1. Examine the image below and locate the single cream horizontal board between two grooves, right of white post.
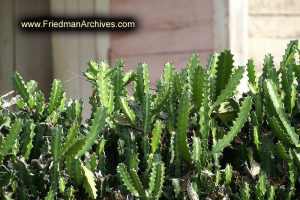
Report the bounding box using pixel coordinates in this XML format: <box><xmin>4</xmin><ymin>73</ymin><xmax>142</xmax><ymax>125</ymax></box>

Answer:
<box><xmin>249</xmin><ymin>15</ymin><xmax>300</xmax><ymax>39</ymax></box>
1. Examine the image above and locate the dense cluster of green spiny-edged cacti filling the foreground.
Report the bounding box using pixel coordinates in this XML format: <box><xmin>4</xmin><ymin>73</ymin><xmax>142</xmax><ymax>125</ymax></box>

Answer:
<box><xmin>0</xmin><ymin>40</ymin><xmax>300</xmax><ymax>200</ymax></box>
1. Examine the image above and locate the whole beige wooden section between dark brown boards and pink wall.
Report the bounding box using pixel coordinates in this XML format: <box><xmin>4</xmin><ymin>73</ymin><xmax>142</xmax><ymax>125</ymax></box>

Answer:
<box><xmin>51</xmin><ymin>0</ymin><xmax>109</xmax><ymax>118</ymax></box>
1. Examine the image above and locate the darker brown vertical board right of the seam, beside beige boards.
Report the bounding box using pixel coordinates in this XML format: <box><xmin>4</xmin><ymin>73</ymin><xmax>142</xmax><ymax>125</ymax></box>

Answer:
<box><xmin>14</xmin><ymin>0</ymin><xmax>52</xmax><ymax>93</ymax></box>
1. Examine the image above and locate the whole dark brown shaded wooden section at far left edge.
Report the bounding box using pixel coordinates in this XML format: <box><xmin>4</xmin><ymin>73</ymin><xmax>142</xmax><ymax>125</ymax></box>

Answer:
<box><xmin>0</xmin><ymin>0</ymin><xmax>52</xmax><ymax>96</ymax></box>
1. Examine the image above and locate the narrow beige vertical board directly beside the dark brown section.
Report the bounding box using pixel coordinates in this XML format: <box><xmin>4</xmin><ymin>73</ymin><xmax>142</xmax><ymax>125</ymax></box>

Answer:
<box><xmin>51</xmin><ymin>0</ymin><xmax>81</xmax><ymax>98</ymax></box>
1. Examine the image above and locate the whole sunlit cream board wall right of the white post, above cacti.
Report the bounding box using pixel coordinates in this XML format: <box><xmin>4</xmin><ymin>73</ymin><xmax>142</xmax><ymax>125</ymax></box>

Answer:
<box><xmin>248</xmin><ymin>0</ymin><xmax>300</xmax><ymax>70</ymax></box>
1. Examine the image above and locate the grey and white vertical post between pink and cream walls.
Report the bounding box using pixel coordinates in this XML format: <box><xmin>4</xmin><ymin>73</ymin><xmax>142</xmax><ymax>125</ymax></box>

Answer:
<box><xmin>213</xmin><ymin>0</ymin><xmax>248</xmax><ymax>65</ymax></box>
